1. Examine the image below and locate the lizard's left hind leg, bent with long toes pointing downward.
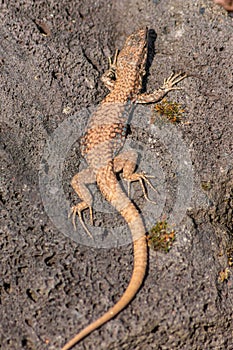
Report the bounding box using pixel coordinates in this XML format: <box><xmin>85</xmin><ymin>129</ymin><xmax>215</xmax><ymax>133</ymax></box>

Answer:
<box><xmin>69</xmin><ymin>168</ymin><xmax>96</xmax><ymax>238</ymax></box>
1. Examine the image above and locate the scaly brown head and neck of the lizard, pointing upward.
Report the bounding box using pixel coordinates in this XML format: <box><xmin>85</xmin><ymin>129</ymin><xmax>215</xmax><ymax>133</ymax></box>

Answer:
<box><xmin>116</xmin><ymin>27</ymin><xmax>148</xmax><ymax>92</ymax></box>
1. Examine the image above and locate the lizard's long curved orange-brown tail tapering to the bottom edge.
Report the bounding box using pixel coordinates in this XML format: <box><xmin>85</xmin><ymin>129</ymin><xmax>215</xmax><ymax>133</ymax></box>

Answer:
<box><xmin>62</xmin><ymin>167</ymin><xmax>147</xmax><ymax>350</ymax></box>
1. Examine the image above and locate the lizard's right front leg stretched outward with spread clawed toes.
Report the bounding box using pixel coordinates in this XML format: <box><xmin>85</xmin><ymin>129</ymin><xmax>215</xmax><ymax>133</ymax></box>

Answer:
<box><xmin>135</xmin><ymin>73</ymin><xmax>187</xmax><ymax>103</ymax></box>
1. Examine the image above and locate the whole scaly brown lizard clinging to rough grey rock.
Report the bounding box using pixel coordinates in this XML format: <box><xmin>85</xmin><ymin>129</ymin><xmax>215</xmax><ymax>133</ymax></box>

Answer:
<box><xmin>62</xmin><ymin>28</ymin><xmax>186</xmax><ymax>350</ymax></box>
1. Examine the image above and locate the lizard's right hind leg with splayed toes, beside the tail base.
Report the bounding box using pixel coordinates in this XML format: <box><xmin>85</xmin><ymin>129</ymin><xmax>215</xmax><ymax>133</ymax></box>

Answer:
<box><xmin>114</xmin><ymin>150</ymin><xmax>157</xmax><ymax>204</ymax></box>
